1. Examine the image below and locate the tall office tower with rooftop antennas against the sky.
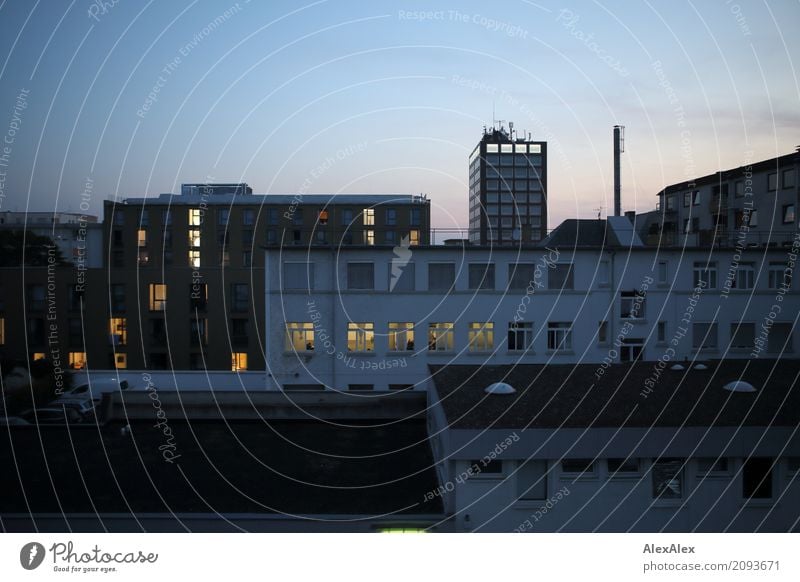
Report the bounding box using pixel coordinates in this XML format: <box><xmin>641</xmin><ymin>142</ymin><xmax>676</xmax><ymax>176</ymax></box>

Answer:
<box><xmin>469</xmin><ymin>125</ymin><xmax>547</xmax><ymax>245</ymax></box>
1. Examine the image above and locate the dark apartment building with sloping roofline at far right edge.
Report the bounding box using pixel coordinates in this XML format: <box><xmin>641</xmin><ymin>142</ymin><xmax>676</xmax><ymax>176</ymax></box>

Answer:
<box><xmin>642</xmin><ymin>152</ymin><xmax>800</xmax><ymax>247</ymax></box>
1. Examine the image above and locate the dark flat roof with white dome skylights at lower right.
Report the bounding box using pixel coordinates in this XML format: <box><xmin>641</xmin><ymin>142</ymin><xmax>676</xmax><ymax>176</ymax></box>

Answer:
<box><xmin>430</xmin><ymin>359</ymin><xmax>800</xmax><ymax>429</ymax></box>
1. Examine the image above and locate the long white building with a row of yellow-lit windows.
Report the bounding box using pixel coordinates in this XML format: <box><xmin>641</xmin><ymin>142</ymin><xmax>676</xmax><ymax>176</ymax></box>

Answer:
<box><xmin>264</xmin><ymin>217</ymin><xmax>800</xmax><ymax>390</ymax></box>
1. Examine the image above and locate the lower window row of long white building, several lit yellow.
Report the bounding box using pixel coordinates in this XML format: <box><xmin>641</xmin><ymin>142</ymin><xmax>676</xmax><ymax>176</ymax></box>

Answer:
<box><xmin>285</xmin><ymin>321</ymin><xmax>794</xmax><ymax>362</ymax></box>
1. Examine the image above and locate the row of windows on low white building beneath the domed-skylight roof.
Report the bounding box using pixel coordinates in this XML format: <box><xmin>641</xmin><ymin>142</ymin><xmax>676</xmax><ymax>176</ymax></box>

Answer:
<box><xmin>478</xmin><ymin>457</ymin><xmax>800</xmax><ymax>501</ymax></box>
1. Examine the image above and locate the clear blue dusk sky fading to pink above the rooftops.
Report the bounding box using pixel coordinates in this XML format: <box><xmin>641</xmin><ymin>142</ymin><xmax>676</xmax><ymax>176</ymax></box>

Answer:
<box><xmin>0</xmin><ymin>0</ymin><xmax>800</xmax><ymax>233</ymax></box>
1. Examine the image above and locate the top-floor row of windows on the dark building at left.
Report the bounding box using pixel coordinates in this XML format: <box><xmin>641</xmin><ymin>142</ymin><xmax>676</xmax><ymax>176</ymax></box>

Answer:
<box><xmin>112</xmin><ymin>207</ymin><xmax>422</xmax><ymax>228</ymax></box>
